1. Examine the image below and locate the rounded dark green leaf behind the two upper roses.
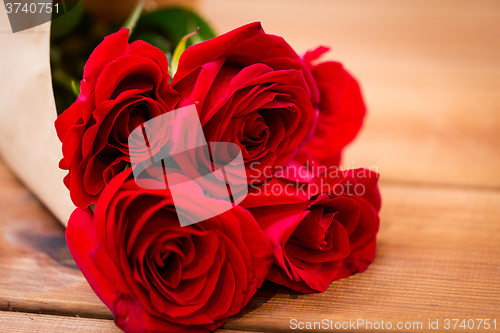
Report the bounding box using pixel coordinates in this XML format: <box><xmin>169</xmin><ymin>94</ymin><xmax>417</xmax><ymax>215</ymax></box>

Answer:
<box><xmin>134</xmin><ymin>7</ymin><xmax>216</xmax><ymax>46</ymax></box>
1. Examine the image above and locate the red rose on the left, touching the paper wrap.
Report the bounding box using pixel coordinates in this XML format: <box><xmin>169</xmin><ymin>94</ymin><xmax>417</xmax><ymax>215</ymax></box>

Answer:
<box><xmin>55</xmin><ymin>29</ymin><xmax>178</xmax><ymax>208</ymax></box>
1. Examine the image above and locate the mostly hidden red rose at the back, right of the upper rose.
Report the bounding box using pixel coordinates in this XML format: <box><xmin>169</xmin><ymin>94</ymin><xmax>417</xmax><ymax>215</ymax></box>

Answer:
<box><xmin>295</xmin><ymin>47</ymin><xmax>366</xmax><ymax>167</ymax></box>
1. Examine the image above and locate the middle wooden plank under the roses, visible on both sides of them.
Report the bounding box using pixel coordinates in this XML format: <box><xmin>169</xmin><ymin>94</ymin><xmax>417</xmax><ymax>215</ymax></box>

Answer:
<box><xmin>0</xmin><ymin>163</ymin><xmax>500</xmax><ymax>332</ymax></box>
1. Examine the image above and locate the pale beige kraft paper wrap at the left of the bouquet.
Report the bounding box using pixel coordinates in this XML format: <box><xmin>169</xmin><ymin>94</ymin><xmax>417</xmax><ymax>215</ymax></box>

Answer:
<box><xmin>0</xmin><ymin>6</ymin><xmax>75</xmax><ymax>225</ymax></box>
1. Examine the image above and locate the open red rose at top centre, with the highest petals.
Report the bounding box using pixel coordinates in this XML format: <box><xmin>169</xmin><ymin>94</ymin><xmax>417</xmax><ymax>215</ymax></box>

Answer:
<box><xmin>172</xmin><ymin>23</ymin><xmax>319</xmax><ymax>187</ymax></box>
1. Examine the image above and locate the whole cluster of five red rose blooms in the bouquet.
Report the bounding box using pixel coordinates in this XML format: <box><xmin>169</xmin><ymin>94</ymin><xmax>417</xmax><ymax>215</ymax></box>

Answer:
<box><xmin>49</xmin><ymin>3</ymin><xmax>380</xmax><ymax>332</ymax></box>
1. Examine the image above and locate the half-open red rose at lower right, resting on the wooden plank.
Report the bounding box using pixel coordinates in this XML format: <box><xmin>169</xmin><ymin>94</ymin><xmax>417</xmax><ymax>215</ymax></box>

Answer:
<box><xmin>242</xmin><ymin>168</ymin><xmax>381</xmax><ymax>293</ymax></box>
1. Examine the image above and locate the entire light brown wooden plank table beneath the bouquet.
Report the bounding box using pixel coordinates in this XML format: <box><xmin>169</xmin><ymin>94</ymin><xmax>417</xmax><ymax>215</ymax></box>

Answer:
<box><xmin>0</xmin><ymin>0</ymin><xmax>500</xmax><ymax>332</ymax></box>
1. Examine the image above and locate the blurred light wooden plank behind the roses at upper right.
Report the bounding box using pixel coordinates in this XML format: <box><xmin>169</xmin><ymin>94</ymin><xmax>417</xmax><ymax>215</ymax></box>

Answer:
<box><xmin>200</xmin><ymin>0</ymin><xmax>500</xmax><ymax>188</ymax></box>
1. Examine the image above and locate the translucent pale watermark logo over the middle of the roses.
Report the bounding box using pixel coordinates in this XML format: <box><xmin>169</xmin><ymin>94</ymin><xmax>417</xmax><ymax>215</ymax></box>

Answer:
<box><xmin>128</xmin><ymin>105</ymin><xmax>248</xmax><ymax>226</ymax></box>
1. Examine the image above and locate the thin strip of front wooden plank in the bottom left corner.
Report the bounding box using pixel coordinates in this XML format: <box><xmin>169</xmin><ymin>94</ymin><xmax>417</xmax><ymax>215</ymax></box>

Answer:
<box><xmin>0</xmin><ymin>311</ymin><xmax>122</xmax><ymax>333</ymax></box>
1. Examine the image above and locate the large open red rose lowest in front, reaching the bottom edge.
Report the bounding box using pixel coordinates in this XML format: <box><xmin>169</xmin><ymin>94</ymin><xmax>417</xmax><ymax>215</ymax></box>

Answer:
<box><xmin>66</xmin><ymin>169</ymin><xmax>272</xmax><ymax>332</ymax></box>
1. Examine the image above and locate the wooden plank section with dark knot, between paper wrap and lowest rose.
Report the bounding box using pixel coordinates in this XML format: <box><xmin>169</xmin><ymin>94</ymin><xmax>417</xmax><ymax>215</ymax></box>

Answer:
<box><xmin>0</xmin><ymin>163</ymin><xmax>112</xmax><ymax>318</ymax></box>
